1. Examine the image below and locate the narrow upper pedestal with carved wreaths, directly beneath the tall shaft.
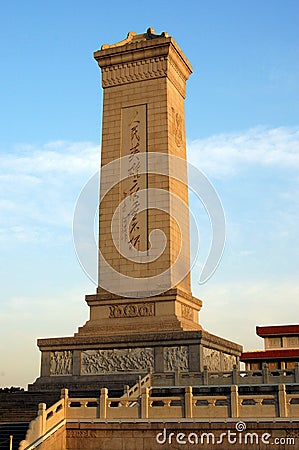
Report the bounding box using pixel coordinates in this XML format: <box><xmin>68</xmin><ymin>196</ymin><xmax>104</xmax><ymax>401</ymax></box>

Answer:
<box><xmin>76</xmin><ymin>288</ymin><xmax>202</xmax><ymax>336</ymax></box>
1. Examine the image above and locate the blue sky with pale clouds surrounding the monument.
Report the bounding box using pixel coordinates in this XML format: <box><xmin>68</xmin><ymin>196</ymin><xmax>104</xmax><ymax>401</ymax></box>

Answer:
<box><xmin>0</xmin><ymin>0</ymin><xmax>299</xmax><ymax>386</ymax></box>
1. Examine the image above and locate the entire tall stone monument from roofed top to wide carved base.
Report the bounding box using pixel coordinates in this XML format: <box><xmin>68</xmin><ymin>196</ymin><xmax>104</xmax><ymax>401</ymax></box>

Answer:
<box><xmin>29</xmin><ymin>28</ymin><xmax>242</xmax><ymax>391</ymax></box>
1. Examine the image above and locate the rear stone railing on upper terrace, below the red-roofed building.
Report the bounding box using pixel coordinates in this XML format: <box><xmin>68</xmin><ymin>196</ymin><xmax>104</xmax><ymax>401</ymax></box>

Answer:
<box><xmin>152</xmin><ymin>363</ymin><xmax>299</xmax><ymax>386</ymax></box>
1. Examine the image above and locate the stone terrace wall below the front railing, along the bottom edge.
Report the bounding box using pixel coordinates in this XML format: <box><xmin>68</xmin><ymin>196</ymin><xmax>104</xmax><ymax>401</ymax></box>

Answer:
<box><xmin>64</xmin><ymin>418</ymin><xmax>299</xmax><ymax>450</ymax></box>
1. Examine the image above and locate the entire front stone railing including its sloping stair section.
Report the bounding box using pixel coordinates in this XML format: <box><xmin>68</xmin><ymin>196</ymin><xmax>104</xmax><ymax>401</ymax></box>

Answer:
<box><xmin>19</xmin><ymin>380</ymin><xmax>299</xmax><ymax>450</ymax></box>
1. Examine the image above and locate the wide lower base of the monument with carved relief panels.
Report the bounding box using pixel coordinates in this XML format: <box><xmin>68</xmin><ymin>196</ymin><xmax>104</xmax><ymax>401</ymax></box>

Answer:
<box><xmin>28</xmin><ymin>326</ymin><xmax>242</xmax><ymax>392</ymax></box>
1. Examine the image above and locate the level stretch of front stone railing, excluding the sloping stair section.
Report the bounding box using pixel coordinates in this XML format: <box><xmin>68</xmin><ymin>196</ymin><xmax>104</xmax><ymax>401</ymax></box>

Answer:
<box><xmin>67</xmin><ymin>384</ymin><xmax>299</xmax><ymax>420</ymax></box>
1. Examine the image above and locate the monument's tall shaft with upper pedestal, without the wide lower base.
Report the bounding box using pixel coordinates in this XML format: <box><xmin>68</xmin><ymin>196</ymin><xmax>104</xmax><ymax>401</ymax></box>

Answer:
<box><xmin>80</xmin><ymin>28</ymin><xmax>201</xmax><ymax>333</ymax></box>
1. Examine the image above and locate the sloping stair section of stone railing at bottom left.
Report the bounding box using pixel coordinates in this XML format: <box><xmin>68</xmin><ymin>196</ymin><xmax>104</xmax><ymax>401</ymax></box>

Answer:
<box><xmin>19</xmin><ymin>389</ymin><xmax>68</xmax><ymax>450</ymax></box>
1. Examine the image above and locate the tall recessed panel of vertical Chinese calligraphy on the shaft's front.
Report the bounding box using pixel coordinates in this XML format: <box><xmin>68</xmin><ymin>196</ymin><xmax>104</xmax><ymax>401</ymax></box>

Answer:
<box><xmin>121</xmin><ymin>105</ymin><xmax>148</xmax><ymax>251</ymax></box>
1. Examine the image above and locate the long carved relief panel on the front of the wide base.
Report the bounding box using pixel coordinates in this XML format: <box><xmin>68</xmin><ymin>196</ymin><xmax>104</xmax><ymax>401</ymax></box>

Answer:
<box><xmin>81</xmin><ymin>348</ymin><xmax>154</xmax><ymax>375</ymax></box>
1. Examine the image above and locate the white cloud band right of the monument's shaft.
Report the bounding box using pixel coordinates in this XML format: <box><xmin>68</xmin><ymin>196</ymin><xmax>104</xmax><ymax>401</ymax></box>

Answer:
<box><xmin>188</xmin><ymin>127</ymin><xmax>299</xmax><ymax>176</ymax></box>
